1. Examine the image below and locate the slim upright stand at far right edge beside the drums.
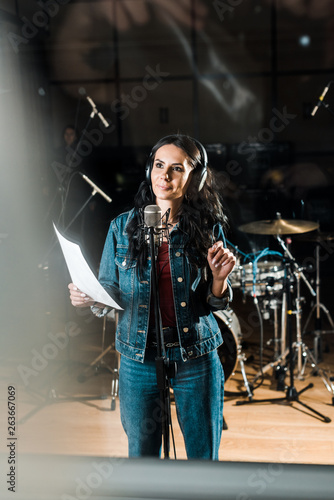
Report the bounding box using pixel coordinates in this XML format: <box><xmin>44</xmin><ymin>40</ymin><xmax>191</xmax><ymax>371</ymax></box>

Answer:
<box><xmin>303</xmin><ymin>242</ymin><xmax>334</xmax><ymax>362</ymax></box>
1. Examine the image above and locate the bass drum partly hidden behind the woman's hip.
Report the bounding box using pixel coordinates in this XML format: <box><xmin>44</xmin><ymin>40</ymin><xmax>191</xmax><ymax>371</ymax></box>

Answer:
<box><xmin>213</xmin><ymin>307</ymin><xmax>241</xmax><ymax>382</ymax></box>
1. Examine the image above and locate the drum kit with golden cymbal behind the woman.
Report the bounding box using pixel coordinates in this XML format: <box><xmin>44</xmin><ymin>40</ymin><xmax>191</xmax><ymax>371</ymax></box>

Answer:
<box><xmin>215</xmin><ymin>214</ymin><xmax>334</xmax><ymax>414</ymax></box>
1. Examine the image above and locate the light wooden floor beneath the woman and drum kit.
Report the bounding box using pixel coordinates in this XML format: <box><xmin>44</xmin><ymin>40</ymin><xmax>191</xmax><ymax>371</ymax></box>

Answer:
<box><xmin>0</xmin><ymin>290</ymin><xmax>334</xmax><ymax>464</ymax></box>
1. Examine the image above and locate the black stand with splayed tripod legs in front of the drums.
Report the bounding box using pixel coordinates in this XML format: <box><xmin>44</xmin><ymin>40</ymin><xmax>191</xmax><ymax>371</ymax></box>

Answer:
<box><xmin>236</xmin><ymin>242</ymin><xmax>331</xmax><ymax>423</ymax></box>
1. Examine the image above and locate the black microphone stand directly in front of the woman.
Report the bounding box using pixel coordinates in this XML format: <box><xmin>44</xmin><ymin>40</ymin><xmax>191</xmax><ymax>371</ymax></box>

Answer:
<box><xmin>146</xmin><ymin>226</ymin><xmax>176</xmax><ymax>459</ymax></box>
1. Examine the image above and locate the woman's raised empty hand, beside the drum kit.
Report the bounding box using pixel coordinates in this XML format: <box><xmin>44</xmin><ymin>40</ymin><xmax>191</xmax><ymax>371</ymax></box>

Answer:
<box><xmin>207</xmin><ymin>241</ymin><xmax>236</xmax><ymax>297</ymax></box>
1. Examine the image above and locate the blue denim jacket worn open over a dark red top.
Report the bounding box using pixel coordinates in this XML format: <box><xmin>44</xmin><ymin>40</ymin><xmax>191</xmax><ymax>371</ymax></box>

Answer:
<box><xmin>99</xmin><ymin>211</ymin><xmax>231</xmax><ymax>362</ymax></box>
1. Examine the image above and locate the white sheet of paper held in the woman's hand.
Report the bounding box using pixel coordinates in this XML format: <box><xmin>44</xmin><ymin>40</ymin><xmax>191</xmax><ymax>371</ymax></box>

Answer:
<box><xmin>53</xmin><ymin>224</ymin><xmax>122</xmax><ymax>310</ymax></box>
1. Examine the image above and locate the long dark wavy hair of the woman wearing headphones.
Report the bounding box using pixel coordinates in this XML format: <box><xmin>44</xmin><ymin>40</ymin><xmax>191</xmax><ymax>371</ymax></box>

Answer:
<box><xmin>127</xmin><ymin>134</ymin><xmax>227</xmax><ymax>276</ymax></box>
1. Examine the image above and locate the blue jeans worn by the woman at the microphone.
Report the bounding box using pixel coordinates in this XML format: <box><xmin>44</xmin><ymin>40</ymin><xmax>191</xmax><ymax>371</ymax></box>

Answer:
<box><xmin>119</xmin><ymin>347</ymin><xmax>224</xmax><ymax>460</ymax></box>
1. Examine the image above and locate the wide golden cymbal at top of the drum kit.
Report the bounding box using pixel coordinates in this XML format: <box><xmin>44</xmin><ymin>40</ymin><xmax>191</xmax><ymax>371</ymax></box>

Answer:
<box><xmin>238</xmin><ymin>218</ymin><xmax>319</xmax><ymax>235</ymax></box>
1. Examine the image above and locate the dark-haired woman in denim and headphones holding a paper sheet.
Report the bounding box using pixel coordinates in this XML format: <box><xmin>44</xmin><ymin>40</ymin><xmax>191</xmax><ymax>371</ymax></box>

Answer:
<box><xmin>69</xmin><ymin>135</ymin><xmax>235</xmax><ymax>460</ymax></box>
